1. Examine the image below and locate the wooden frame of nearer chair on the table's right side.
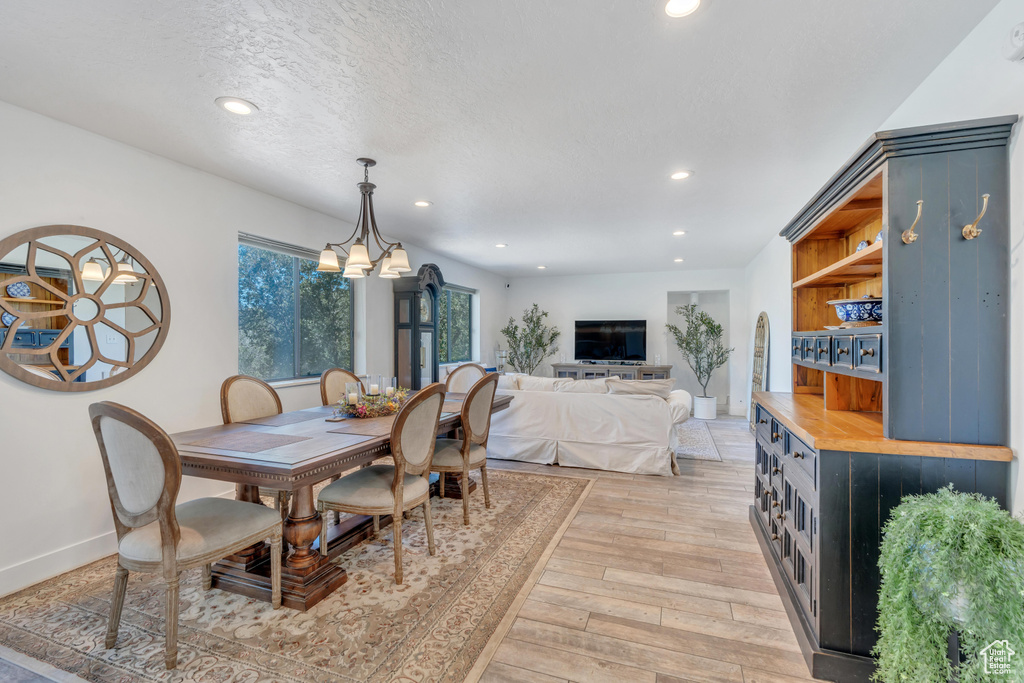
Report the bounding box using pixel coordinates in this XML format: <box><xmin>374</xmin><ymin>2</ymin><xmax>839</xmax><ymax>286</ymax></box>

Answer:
<box><xmin>316</xmin><ymin>382</ymin><xmax>444</xmax><ymax>585</ymax></box>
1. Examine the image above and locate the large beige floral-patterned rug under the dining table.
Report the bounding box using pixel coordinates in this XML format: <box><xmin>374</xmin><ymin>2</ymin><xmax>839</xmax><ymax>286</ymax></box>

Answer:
<box><xmin>0</xmin><ymin>469</ymin><xmax>589</xmax><ymax>683</ymax></box>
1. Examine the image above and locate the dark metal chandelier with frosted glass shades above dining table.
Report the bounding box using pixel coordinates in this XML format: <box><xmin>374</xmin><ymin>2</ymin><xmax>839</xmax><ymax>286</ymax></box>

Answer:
<box><xmin>316</xmin><ymin>159</ymin><xmax>413</xmax><ymax>279</ymax></box>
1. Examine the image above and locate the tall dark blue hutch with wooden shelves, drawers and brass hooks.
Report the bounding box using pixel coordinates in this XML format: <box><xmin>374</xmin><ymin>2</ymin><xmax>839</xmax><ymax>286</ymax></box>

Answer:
<box><xmin>751</xmin><ymin>116</ymin><xmax>1017</xmax><ymax>681</ymax></box>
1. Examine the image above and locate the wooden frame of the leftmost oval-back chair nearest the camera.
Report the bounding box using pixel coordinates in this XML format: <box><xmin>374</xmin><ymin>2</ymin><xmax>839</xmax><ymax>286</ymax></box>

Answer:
<box><xmin>89</xmin><ymin>401</ymin><xmax>282</xmax><ymax>669</ymax></box>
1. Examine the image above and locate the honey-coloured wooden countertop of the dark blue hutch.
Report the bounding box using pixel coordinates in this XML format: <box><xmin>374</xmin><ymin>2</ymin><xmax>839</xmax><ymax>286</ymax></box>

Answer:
<box><xmin>754</xmin><ymin>391</ymin><xmax>1014</xmax><ymax>462</ymax></box>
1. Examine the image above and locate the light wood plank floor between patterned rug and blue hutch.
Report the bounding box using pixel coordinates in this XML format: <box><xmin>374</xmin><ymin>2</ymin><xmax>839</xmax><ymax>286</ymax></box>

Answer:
<box><xmin>482</xmin><ymin>419</ymin><xmax>811</xmax><ymax>683</ymax></box>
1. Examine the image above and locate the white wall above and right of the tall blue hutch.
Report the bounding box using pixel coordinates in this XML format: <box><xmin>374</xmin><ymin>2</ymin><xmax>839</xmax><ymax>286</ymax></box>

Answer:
<box><xmin>884</xmin><ymin>0</ymin><xmax>1024</xmax><ymax>513</ymax></box>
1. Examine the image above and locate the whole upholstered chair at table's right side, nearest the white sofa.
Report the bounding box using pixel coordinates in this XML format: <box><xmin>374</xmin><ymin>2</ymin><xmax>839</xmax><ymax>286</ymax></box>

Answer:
<box><xmin>430</xmin><ymin>373</ymin><xmax>498</xmax><ymax>524</ymax></box>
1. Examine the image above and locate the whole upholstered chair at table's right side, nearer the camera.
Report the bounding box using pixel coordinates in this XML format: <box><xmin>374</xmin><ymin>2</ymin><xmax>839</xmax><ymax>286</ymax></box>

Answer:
<box><xmin>316</xmin><ymin>383</ymin><xmax>444</xmax><ymax>585</ymax></box>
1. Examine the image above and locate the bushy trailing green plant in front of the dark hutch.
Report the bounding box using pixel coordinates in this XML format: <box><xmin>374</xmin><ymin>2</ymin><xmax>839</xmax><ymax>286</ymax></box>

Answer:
<box><xmin>872</xmin><ymin>485</ymin><xmax>1024</xmax><ymax>683</ymax></box>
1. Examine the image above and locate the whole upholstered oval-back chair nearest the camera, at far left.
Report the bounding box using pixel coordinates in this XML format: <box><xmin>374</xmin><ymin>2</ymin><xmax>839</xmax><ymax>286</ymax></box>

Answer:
<box><xmin>89</xmin><ymin>401</ymin><xmax>282</xmax><ymax>669</ymax></box>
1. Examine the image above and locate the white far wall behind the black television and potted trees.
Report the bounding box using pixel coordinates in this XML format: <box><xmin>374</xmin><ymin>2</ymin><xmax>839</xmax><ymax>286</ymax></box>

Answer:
<box><xmin>499</xmin><ymin>269</ymin><xmax>753</xmax><ymax>415</ymax></box>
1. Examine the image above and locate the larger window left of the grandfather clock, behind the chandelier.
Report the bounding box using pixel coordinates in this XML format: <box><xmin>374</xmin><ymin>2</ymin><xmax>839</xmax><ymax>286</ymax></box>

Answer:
<box><xmin>239</xmin><ymin>236</ymin><xmax>352</xmax><ymax>380</ymax></box>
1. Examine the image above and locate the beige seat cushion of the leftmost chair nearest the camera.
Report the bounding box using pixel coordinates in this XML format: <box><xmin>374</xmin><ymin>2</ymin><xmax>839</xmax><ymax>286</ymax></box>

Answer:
<box><xmin>118</xmin><ymin>498</ymin><xmax>281</xmax><ymax>564</ymax></box>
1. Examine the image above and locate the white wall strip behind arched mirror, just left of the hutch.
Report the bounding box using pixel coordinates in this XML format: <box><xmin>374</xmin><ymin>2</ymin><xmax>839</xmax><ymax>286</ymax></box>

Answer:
<box><xmin>743</xmin><ymin>236</ymin><xmax>793</xmax><ymax>392</ymax></box>
